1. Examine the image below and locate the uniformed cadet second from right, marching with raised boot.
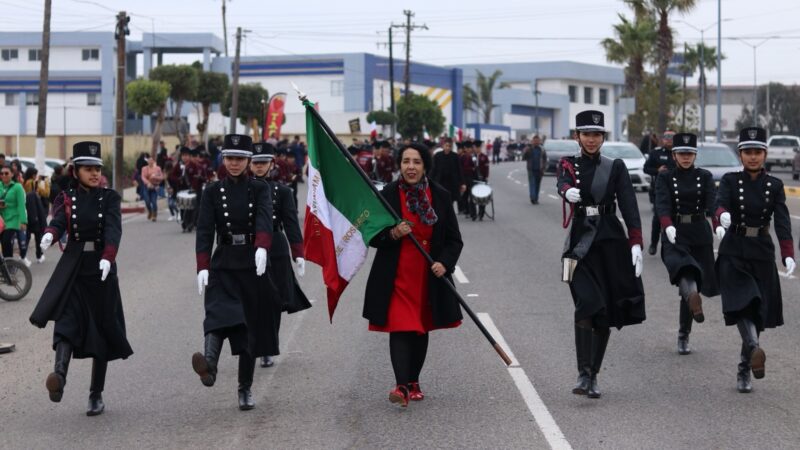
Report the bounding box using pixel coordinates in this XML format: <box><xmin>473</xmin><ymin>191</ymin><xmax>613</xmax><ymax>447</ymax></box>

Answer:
<box><xmin>655</xmin><ymin>133</ymin><xmax>719</xmax><ymax>355</ymax></box>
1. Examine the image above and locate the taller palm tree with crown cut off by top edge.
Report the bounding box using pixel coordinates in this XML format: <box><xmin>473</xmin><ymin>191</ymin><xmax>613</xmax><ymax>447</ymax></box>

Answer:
<box><xmin>636</xmin><ymin>0</ymin><xmax>697</xmax><ymax>131</ymax></box>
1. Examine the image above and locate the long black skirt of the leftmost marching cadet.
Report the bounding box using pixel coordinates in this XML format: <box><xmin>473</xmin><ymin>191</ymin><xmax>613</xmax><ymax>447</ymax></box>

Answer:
<box><xmin>48</xmin><ymin>252</ymin><xmax>133</xmax><ymax>361</ymax></box>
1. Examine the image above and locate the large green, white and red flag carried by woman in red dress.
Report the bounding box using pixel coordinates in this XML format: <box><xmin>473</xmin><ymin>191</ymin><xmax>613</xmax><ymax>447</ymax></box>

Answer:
<box><xmin>303</xmin><ymin>101</ymin><xmax>397</xmax><ymax>321</ymax></box>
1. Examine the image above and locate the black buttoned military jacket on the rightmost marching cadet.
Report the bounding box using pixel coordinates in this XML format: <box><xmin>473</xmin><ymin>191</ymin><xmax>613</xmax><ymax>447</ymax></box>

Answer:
<box><xmin>715</xmin><ymin>170</ymin><xmax>794</xmax><ymax>261</ymax></box>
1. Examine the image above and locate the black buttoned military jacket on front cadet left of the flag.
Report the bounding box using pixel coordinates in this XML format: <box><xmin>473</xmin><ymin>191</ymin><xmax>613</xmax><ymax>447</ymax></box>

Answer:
<box><xmin>195</xmin><ymin>175</ymin><xmax>273</xmax><ymax>272</ymax></box>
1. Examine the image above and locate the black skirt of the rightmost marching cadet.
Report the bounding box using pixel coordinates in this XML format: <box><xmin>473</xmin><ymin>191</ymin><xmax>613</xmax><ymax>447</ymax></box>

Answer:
<box><xmin>716</xmin><ymin>255</ymin><xmax>783</xmax><ymax>331</ymax></box>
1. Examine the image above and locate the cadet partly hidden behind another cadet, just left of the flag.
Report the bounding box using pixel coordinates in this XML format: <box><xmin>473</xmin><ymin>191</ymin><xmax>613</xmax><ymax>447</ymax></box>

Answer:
<box><xmin>250</xmin><ymin>142</ymin><xmax>311</xmax><ymax>367</ymax></box>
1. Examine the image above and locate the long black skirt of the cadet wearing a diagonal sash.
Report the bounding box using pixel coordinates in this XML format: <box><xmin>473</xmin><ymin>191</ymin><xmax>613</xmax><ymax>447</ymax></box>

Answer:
<box><xmin>569</xmin><ymin>239</ymin><xmax>646</xmax><ymax>329</ymax></box>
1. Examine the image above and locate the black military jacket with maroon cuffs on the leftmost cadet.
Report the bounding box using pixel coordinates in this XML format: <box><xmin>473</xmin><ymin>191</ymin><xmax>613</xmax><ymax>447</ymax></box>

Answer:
<box><xmin>45</xmin><ymin>186</ymin><xmax>122</xmax><ymax>263</ymax></box>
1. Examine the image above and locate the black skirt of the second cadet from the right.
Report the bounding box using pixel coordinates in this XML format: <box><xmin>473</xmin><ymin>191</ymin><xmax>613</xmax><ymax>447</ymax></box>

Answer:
<box><xmin>661</xmin><ymin>233</ymin><xmax>719</xmax><ymax>297</ymax></box>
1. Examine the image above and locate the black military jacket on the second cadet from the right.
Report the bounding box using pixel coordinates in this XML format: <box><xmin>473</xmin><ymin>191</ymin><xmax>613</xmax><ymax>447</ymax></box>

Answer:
<box><xmin>655</xmin><ymin>166</ymin><xmax>717</xmax><ymax>245</ymax></box>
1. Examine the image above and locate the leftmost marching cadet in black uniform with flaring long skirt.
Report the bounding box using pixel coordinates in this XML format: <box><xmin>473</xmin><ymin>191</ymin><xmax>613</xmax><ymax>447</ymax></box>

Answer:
<box><xmin>30</xmin><ymin>142</ymin><xmax>133</xmax><ymax>416</ymax></box>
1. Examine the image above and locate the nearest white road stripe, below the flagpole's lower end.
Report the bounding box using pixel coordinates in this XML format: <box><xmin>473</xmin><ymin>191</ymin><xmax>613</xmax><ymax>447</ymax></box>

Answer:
<box><xmin>478</xmin><ymin>313</ymin><xmax>572</xmax><ymax>450</ymax></box>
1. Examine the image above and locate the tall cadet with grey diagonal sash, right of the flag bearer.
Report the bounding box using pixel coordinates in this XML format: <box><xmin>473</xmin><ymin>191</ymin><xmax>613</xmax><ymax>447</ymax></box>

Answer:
<box><xmin>556</xmin><ymin>111</ymin><xmax>645</xmax><ymax>398</ymax></box>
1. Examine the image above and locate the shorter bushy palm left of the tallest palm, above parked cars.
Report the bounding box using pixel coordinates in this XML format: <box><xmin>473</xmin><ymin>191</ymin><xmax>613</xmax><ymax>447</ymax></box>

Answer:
<box><xmin>600</xmin><ymin>14</ymin><xmax>656</xmax><ymax>139</ymax></box>
